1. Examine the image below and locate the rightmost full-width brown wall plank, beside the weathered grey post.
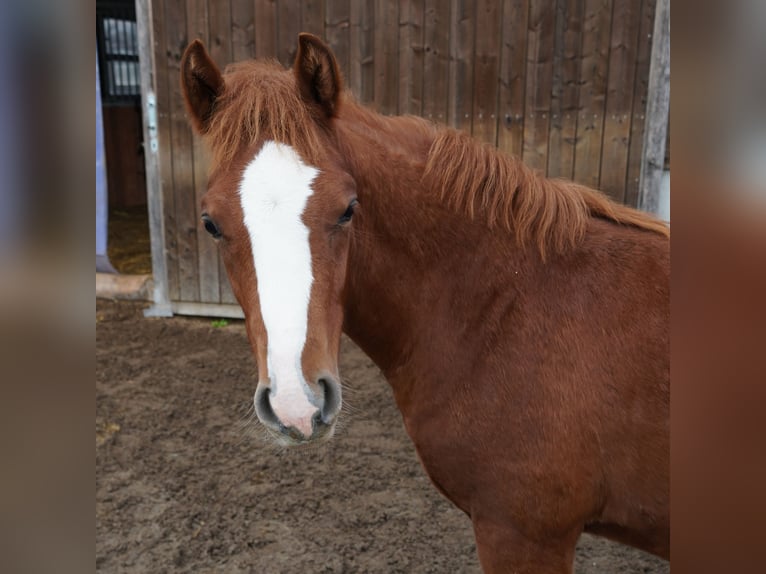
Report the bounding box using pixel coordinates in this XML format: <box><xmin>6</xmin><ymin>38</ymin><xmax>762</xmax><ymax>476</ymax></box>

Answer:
<box><xmin>600</xmin><ymin>0</ymin><xmax>641</xmax><ymax>203</ymax></box>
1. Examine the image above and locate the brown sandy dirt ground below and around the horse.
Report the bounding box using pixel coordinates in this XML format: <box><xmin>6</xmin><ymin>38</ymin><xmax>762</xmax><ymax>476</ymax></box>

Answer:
<box><xmin>96</xmin><ymin>300</ymin><xmax>670</xmax><ymax>574</ymax></box>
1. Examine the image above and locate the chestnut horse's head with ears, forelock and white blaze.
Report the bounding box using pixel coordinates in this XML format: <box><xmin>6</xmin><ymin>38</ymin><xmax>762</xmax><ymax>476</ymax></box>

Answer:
<box><xmin>181</xmin><ymin>34</ymin><xmax>357</xmax><ymax>445</ymax></box>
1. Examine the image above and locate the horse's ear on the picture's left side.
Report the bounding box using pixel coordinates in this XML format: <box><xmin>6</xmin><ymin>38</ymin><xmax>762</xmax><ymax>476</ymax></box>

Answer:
<box><xmin>181</xmin><ymin>40</ymin><xmax>224</xmax><ymax>134</ymax></box>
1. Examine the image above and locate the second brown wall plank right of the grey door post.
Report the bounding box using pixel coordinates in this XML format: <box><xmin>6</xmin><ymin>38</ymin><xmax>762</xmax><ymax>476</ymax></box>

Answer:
<box><xmin>165</xmin><ymin>0</ymin><xmax>200</xmax><ymax>301</ymax></box>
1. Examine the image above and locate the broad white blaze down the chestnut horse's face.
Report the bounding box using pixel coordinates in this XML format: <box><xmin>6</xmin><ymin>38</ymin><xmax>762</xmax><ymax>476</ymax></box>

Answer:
<box><xmin>239</xmin><ymin>141</ymin><xmax>319</xmax><ymax>436</ymax></box>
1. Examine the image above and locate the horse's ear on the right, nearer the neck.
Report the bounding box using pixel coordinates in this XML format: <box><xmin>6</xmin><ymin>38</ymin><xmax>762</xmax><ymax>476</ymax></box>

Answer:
<box><xmin>293</xmin><ymin>33</ymin><xmax>343</xmax><ymax>118</ymax></box>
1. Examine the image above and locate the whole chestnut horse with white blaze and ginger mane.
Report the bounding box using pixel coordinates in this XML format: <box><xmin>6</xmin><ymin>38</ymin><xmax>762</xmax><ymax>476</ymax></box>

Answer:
<box><xmin>181</xmin><ymin>34</ymin><xmax>670</xmax><ymax>573</ymax></box>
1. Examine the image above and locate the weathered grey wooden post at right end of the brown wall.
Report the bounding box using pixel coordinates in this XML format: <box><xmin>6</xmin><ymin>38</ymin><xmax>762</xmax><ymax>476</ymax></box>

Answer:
<box><xmin>638</xmin><ymin>0</ymin><xmax>670</xmax><ymax>213</ymax></box>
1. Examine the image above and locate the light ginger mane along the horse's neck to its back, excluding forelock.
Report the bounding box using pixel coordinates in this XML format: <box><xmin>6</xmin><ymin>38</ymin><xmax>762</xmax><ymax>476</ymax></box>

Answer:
<box><xmin>423</xmin><ymin>129</ymin><xmax>670</xmax><ymax>257</ymax></box>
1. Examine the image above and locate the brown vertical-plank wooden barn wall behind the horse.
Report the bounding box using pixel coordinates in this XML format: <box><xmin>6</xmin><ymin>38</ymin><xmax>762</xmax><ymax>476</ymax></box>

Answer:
<box><xmin>152</xmin><ymin>0</ymin><xmax>656</xmax><ymax>303</ymax></box>
